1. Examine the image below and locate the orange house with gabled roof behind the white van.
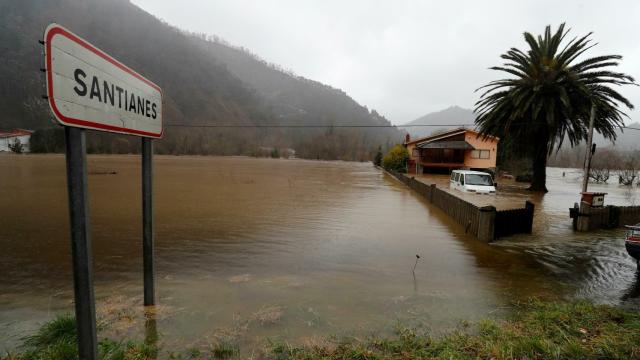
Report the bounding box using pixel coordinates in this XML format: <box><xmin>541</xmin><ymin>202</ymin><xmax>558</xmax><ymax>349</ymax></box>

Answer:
<box><xmin>404</xmin><ymin>128</ymin><xmax>500</xmax><ymax>174</ymax></box>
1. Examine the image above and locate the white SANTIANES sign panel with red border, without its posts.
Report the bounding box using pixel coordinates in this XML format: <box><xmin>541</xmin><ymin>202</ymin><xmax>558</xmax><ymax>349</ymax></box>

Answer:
<box><xmin>44</xmin><ymin>24</ymin><xmax>162</xmax><ymax>138</ymax></box>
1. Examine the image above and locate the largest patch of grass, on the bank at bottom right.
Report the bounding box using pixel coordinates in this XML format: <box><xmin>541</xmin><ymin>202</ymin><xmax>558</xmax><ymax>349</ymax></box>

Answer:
<box><xmin>267</xmin><ymin>300</ymin><xmax>640</xmax><ymax>360</ymax></box>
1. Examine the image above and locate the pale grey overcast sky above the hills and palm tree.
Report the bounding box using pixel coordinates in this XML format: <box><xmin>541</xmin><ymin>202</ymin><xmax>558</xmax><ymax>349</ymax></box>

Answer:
<box><xmin>132</xmin><ymin>0</ymin><xmax>640</xmax><ymax>124</ymax></box>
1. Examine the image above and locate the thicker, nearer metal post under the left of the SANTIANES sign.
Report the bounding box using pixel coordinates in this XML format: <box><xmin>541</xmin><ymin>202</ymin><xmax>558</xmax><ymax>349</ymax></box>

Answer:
<box><xmin>64</xmin><ymin>127</ymin><xmax>98</xmax><ymax>359</ymax></box>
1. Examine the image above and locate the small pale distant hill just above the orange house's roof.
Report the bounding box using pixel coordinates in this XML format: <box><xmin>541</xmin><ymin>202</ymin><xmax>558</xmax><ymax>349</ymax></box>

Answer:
<box><xmin>400</xmin><ymin>106</ymin><xmax>475</xmax><ymax>138</ymax></box>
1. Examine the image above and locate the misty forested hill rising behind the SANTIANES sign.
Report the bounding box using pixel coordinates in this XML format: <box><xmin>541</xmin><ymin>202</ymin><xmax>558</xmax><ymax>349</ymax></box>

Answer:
<box><xmin>0</xmin><ymin>0</ymin><xmax>402</xmax><ymax>160</ymax></box>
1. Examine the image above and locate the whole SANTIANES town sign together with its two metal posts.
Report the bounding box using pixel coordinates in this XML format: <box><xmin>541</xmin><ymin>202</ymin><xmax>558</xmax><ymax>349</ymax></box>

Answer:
<box><xmin>41</xmin><ymin>24</ymin><xmax>163</xmax><ymax>360</ymax></box>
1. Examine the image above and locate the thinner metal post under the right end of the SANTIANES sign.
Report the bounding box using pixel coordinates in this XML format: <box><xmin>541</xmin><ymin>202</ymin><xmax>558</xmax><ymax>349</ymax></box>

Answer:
<box><xmin>142</xmin><ymin>138</ymin><xmax>155</xmax><ymax>306</ymax></box>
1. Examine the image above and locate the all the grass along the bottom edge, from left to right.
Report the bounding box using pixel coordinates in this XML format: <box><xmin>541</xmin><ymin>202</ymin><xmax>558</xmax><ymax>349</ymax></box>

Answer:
<box><xmin>0</xmin><ymin>300</ymin><xmax>640</xmax><ymax>360</ymax></box>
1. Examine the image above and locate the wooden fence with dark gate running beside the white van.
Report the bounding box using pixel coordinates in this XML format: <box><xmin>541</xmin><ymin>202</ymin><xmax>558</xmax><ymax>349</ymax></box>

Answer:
<box><xmin>389</xmin><ymin>171</ymin><xmax>535</xmax><ymax>242</ymax></box>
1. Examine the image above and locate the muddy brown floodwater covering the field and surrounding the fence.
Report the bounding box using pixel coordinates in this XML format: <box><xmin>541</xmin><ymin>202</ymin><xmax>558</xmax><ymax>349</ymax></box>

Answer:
<box><xmin>0</xmin><ymin>155</ymin><xmax>640</xmax><ymax>355</ymax></box>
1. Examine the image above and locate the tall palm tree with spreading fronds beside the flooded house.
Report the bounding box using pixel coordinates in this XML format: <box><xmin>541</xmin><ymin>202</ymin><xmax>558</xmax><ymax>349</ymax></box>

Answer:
<box><xmin>475</xmin><ymin>24</ymin><xmax>636</xmax><ymax>192</ymax></box>
